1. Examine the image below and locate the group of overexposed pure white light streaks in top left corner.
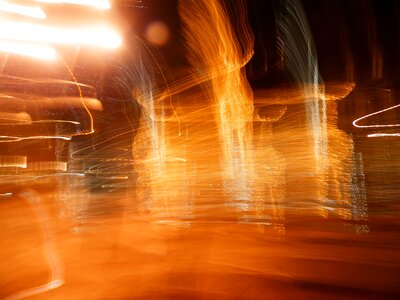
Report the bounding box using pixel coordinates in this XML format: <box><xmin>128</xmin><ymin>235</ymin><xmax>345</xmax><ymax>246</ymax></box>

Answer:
<box><xmin>0</xmin><ymin>0</ymin><xmax>121</xmax><ymax>60</ymax></box>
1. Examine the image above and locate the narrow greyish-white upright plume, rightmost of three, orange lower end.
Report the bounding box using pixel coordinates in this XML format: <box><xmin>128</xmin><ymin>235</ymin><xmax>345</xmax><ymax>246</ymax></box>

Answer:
<box><xmin>278</xmin><ymin>0</ymin><xmax>328</xmax><ymax>169</ymax></box>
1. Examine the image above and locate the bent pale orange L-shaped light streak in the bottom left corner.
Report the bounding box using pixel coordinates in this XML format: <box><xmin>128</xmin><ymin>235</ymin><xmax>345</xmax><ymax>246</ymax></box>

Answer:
<box><xmin>6</xmin><ymin>190</ymin><xmax>64</xmax><ymax>300</ymax></box>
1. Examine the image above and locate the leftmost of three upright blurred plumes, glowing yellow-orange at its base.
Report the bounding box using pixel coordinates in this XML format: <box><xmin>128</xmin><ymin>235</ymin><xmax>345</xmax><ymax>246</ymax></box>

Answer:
<box><xmin>126</xmin><ymin>38</ymin><xmax>187</xmax><ymax>220</ymax></box>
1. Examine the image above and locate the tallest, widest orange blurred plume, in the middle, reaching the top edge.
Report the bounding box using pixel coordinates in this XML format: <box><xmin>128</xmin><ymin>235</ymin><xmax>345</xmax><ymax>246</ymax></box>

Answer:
<box><xmin>179</xmin><ymin>0</ymin><xmax>254</xmax><ymax>216</ymax></box>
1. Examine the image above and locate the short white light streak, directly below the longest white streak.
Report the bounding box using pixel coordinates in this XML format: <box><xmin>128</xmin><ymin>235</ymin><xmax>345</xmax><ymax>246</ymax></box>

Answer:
<box><xmin>0</xmin><ymin>39</ymin><xmax>57</xmax><ymax>60</ymax></box>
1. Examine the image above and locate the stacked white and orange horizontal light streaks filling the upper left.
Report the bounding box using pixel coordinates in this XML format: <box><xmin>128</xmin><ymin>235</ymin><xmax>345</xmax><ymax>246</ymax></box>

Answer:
<box><xmin>0</xmin><ymin>0</ymin><xmax>121</xmax><ymax>190</ymax></box>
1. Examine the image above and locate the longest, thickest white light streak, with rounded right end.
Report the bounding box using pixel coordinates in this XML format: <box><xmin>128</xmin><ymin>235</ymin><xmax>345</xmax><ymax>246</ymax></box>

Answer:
<box><xmin>0</xmin><ymin>21</ymin><xmax>121</xmax><ymax>49</ymax></box>
